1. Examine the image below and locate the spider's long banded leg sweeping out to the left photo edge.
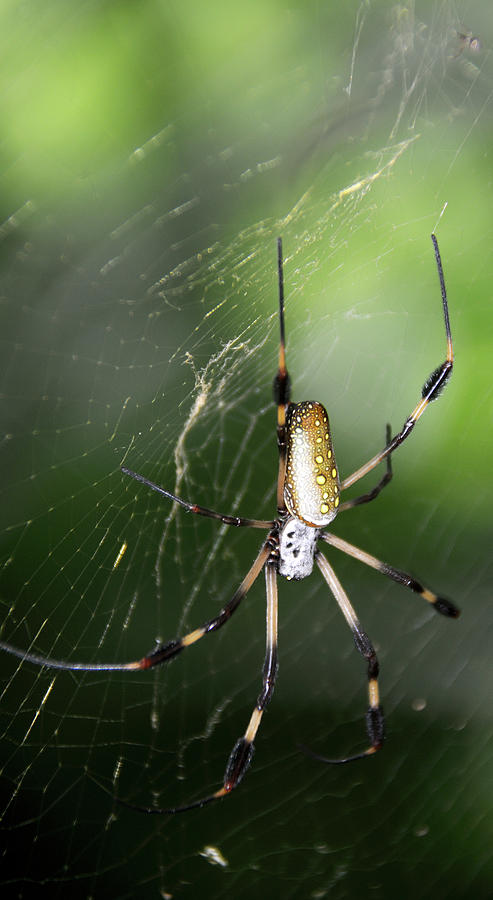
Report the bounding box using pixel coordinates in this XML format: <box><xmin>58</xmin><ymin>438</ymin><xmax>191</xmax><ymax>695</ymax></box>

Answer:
<box><xmin>0</xmin><ymin>539</ymin><xmax>272</xmax><ymax>672</ymax></box>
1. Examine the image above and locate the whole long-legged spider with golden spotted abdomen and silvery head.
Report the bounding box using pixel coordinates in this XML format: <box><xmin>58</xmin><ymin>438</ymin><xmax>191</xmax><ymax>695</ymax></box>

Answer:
<box><xmin>0</xmin><ymin>234</ymin><xmax>459</xmax><ymax>814</ymax></box>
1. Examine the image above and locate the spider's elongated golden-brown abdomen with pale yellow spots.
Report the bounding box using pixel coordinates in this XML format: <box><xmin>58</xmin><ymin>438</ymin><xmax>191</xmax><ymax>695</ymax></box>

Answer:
<box><xmin>284</xmin><ymin>400</ymin><xmax>340</xmax><ymax>528</ymax></box>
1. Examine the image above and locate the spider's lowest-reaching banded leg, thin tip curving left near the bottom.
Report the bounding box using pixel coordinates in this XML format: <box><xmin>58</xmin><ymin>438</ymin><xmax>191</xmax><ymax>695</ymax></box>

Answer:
<box><xmin>114</xmin><ymin>559</ymin><xmax>278</xmax><ymax>815</ymax></box>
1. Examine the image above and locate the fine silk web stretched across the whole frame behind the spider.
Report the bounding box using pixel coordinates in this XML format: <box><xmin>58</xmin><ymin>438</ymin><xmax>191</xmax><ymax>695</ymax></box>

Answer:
<box><xmin>0</xmin><ymin>0</ymin><xmax>493</xmax><ymax>898</ymax></box>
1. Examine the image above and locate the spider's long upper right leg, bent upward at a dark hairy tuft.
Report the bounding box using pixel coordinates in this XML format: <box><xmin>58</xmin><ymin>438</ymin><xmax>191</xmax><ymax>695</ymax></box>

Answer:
<box><xmin>341</xmin><ymin>234</ymin><xmax>454</xmax><ymax>491</ymax></box>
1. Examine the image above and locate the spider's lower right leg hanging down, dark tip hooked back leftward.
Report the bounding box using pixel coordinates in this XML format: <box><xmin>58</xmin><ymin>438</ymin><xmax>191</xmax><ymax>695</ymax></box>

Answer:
<box><xmin>303</xmin><ymin>551</ymin><xmax>384</xmax><ymax>764</ymax></box>
